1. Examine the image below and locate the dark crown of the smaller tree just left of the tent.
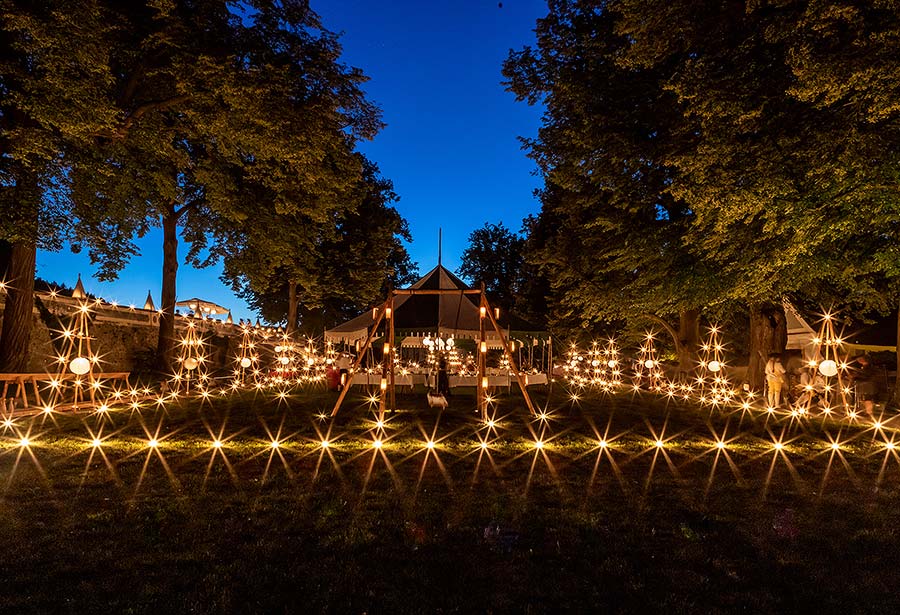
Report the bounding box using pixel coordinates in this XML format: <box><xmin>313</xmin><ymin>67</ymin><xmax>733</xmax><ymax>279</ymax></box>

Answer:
<box><xmin>218</xmin><ymin>155</ymin><xmax>417</xmax><ymax>331</ymax></box>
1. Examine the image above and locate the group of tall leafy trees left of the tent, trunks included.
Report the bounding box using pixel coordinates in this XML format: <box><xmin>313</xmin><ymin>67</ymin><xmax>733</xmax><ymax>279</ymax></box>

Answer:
<box><xmin>0</xmin><ymin>0</ymin><xmax>414</xmax><ymax>372</ymax></box>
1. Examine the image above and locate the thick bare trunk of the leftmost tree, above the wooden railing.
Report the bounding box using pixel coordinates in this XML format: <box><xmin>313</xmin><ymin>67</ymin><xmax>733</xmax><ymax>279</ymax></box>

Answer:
<box><xmin>0</xmin><ymin>241</ymin><xmax>37</xmax><ymax>373</ymax></box>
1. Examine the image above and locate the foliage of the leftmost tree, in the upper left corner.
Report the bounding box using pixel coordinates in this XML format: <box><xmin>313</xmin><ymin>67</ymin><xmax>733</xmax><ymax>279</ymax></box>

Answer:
<box><xmin>0</xmin><ymin>0</ymin><xmax>114</xmax><ymax>249</ymax></box>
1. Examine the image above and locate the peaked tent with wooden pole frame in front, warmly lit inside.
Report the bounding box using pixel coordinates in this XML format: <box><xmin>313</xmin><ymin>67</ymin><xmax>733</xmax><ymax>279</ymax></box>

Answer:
<box><xmin>325</xmin><ymin>263</ymin><xmax>552</xmax><ymax>422</ymax></box>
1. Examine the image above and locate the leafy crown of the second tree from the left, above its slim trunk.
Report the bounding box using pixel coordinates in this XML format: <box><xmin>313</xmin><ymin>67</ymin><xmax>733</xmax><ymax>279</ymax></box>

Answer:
<box><xmin>65</xmin><ymin>1</ymin><xmax>380</xmax><ymax>278</ymax></box>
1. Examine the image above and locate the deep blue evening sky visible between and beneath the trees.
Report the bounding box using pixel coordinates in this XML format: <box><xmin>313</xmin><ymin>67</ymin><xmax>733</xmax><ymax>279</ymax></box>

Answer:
<box><xmin>38</xmin><ymin>0</ymin><xmax>547</xmax><ymax>319</ymax></box>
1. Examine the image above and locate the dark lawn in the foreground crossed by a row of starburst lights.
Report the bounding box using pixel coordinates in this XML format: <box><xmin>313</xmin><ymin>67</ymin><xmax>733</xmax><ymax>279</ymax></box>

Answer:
<box><xmin>0</xmin><ymin>390</ymin><xmax>900</xmax><ymax>613</ymax></box>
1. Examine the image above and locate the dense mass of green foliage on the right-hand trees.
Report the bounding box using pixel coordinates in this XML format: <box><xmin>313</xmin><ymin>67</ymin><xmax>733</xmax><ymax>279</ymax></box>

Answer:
<box><xmin>504</xmin><ymin>0</ymin><xmax>900</xmax><ymax>336</ymax></box>
